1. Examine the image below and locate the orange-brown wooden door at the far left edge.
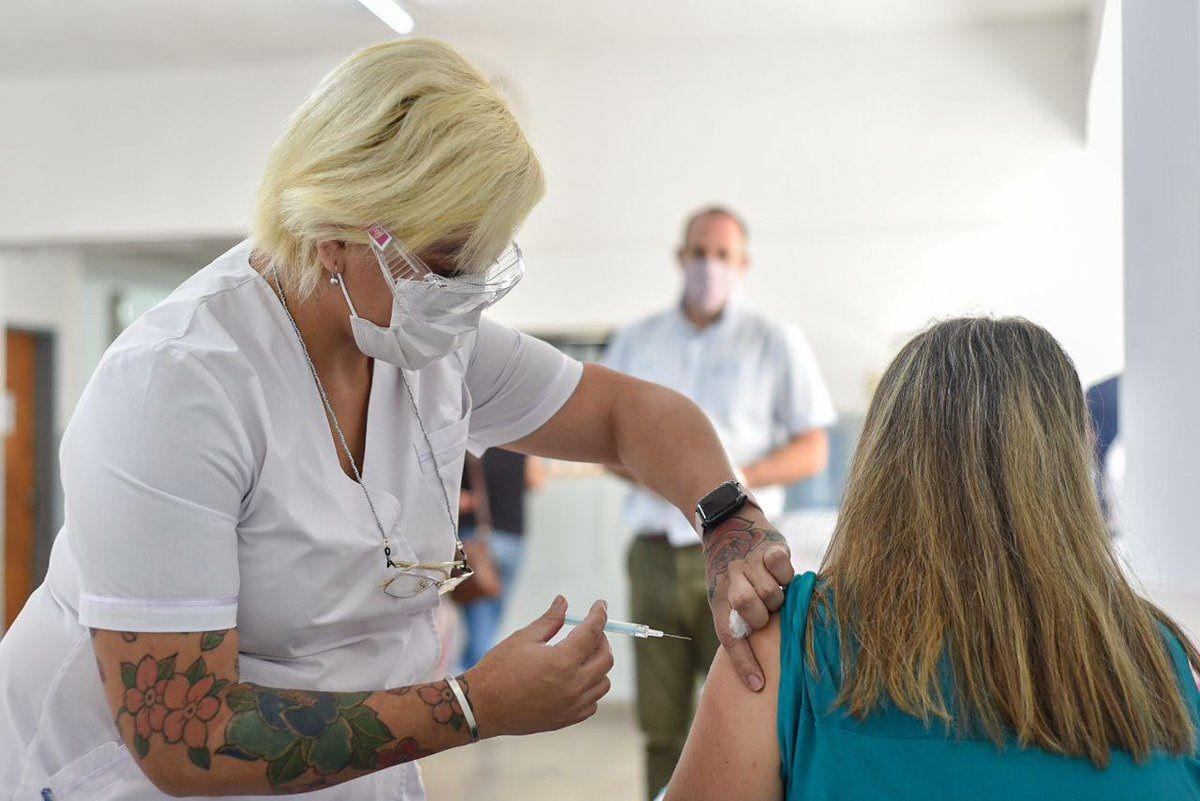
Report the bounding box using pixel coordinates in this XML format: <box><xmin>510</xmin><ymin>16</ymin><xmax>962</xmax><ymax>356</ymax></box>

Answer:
<box><xmin>4</xmin><ymin>330</ymin><xmax>37</xmax><ymax>628</ymax></box>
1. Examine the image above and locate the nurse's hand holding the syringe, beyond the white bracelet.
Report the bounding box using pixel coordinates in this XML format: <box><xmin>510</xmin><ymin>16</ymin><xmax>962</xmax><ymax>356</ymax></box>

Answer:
<box><xmin>466</xmin><ymin>596</ymin><xmax>612</xmax><ymax>737</ymax></box>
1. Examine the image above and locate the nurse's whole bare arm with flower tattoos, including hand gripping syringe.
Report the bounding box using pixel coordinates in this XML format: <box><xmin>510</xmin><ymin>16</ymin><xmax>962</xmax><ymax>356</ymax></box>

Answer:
<box><xmin>92</xmin><ymin>602</ymin><xmax>612</xmax><ymax>796</ymax></box>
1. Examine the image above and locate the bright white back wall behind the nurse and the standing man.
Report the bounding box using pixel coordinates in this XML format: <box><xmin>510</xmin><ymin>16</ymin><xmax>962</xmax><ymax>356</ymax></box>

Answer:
<box><xmin>0</xmin><ymin>18</ymin><xmax>1121</xmax><ymax>409</ymax></box>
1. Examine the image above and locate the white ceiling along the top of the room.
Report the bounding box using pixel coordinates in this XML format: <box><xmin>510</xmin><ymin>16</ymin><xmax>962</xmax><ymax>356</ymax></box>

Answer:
<box><xmin>0</xmin><ymin>0</ymin><xmax>1096</xmax><ymax>77</ymax></box>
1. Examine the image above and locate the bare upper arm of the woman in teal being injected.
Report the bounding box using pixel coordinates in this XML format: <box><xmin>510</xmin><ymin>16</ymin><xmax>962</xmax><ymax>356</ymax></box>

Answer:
<box><xmin>666</xmin><ymin>615</ymin><xmax>784</xmax><ymax>801</ymax></box>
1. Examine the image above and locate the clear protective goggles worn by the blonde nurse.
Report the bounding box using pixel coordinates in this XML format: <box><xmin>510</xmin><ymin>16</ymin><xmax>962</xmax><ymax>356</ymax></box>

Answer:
<box><xmin>366</xmin><ymin>225</ymin><xmax>524</xmax><ymax>324</ymax></box>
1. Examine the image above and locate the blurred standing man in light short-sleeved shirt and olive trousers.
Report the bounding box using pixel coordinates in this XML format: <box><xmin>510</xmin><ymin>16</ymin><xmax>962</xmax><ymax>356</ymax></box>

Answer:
<box><xmin>605</xmin><ymin>207</ymin><xmax>834</xmax><ymax>797</ymax></box>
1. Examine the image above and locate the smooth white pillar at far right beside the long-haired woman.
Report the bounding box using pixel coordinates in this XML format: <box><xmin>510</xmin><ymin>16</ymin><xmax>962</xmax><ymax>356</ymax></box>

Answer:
<box><xmin>1121</xmin><ymin>0</ymin><xmax>1200</xmax><ymax>637</ymax></box>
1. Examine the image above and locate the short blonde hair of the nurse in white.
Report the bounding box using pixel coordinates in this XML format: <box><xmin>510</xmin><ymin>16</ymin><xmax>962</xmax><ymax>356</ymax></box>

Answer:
<box><xmin>251</xmin><ymin>38</ymin><xmax>545</xmax><ymax>296</ymax></box>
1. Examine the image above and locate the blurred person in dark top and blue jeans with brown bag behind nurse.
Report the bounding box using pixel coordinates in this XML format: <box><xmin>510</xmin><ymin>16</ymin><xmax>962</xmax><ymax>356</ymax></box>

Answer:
<box><xmin>456</xmin><ymin>447</ymin><xmax>546</xmax><ymax>670</ymax></box>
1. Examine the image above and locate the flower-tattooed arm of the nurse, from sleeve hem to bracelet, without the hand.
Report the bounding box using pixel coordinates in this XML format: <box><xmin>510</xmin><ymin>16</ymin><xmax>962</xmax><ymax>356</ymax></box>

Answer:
<box><xmin>92</xmin><ymin>631</ymin><xmax>470</xmax><ymax>795</ymax></box>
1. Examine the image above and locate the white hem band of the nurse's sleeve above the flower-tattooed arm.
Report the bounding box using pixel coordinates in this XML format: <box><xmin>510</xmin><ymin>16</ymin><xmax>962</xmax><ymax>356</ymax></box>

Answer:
<box><xmin>79</xmin><ymin>592</ymin><xmax>238</xmax><ymax>633</ymax></box>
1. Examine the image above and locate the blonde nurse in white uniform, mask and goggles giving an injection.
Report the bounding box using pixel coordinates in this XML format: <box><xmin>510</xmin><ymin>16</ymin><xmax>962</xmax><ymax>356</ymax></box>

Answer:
<box><xmin>0</xmin><ymin>40</ymin><xmax>791</xmax><ymax>801</ymax></box>
